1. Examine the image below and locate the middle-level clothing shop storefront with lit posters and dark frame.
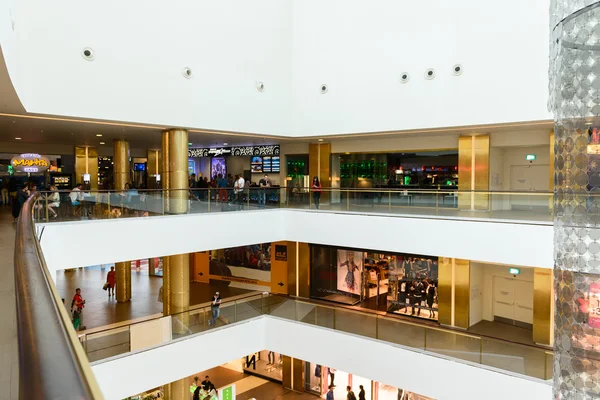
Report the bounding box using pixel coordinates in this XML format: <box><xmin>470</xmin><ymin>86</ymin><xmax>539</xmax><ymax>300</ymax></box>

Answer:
<box><xmin>310</xmin><ymin>245</ymin><xmax>438</xmax><ymax>321</ymax></box>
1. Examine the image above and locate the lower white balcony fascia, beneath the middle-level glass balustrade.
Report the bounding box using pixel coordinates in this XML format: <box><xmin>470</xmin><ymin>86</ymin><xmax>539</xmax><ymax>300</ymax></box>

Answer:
<box><xmin>92</xmin><ymin>316</ymin><xmax>552</xmax><ymax>400</ymax></box>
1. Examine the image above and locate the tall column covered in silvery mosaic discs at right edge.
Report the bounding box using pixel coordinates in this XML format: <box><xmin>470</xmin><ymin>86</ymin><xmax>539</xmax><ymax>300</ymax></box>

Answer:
<box><xmin>549</xmin><ymin>0</ymin><xmax>600</xmax><ymax>400</ymax></box>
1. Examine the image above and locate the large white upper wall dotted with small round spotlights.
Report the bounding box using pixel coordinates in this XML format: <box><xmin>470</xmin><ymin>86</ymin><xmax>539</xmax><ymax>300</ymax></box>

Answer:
<box><xmin>0</xmin><ymin>0</ymin><xmax>551</xmax><ymax>136</ymax></box>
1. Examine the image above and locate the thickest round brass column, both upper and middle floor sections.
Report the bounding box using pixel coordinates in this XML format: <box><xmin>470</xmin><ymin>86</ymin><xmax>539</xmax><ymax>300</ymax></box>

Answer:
<box><xmin>160</xmin><ymin>129</ymin><xmax>190</xmax><ymax>333</ymax></box>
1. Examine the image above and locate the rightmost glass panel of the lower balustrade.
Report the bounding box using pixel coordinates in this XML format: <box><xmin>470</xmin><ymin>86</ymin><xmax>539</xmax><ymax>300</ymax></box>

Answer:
<box><xmin>481</xmin><ymin>339</ymin><xmax>547</xmax><ymax>379</ymax></box>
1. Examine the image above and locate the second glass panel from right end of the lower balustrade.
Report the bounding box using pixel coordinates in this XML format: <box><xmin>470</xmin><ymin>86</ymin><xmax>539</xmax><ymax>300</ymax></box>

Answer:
<box><xmin>425</xmin><ymin>329</ymin><xmax>481</xmax><ymax>363</ymax></box>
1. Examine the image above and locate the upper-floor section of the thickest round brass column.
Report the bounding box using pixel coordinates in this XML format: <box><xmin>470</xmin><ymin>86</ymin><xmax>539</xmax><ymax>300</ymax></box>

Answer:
<box><xmin>160</xmin><ymin>129</ymin><xmax>188</xmax><ymax>214</ymax></box>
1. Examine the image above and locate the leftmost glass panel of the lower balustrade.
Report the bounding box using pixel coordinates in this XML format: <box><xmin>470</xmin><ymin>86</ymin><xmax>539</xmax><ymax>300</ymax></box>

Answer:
<box><xmin>82</xmin><ymin>326</ymin><xmax>130</xmax><ymax>362</ymax></box>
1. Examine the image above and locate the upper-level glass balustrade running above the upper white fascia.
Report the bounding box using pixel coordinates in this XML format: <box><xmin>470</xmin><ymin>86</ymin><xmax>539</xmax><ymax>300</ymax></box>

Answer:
<box><xmin>34</xmin><ymin>187</ymin><xmax>553</xmax><ymax>223</ymax></box>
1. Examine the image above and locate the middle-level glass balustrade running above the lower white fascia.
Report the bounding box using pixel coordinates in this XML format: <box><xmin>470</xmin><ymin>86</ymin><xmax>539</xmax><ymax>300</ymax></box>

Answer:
<box><xmin>79</xmin><ymin>293</ymin><xmax>553</xmax><ymax>380</ymax></box>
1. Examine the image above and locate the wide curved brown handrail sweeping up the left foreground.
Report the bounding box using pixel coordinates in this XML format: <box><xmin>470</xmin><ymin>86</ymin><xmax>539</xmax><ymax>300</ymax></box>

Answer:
<box><xmin>14</xmin><ymin>194</ymin><xmax>103</xmax><ymax>400</ymax></box>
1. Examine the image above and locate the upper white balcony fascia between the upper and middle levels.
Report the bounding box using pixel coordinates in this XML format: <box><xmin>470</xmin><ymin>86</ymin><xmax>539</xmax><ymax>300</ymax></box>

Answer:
<box><xmin>38</xmin><ymin>210</ymin><xmax>554</xmax><ymax>271</ymax></box>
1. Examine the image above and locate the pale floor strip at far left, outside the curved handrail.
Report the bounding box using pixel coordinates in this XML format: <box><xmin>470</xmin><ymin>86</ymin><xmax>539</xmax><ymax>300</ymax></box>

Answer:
<box><xmin>0</xmin><ymin>206</ymin><xmax>19</xmax><ymax>400</ymax></box>
